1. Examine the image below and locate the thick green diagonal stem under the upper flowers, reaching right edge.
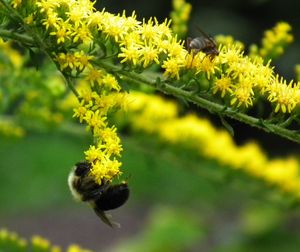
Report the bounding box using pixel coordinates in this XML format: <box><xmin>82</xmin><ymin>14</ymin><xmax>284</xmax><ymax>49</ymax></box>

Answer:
<box><xmin>98</xmin><ymin>61</ymin><xmax>300</xmax><ymax>143</ymax></box>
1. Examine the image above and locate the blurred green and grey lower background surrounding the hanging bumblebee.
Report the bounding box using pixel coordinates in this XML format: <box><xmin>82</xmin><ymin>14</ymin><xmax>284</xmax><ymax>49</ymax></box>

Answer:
<box><xmin>0</xmin><ymin>129</ymin><xmax>300</xmax><ymax>251</ymax></box>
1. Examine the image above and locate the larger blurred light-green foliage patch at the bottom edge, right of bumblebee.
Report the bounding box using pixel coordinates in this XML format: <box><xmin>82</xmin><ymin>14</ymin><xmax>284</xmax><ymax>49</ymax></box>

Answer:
<box><xmin>113</xmin><ymin>207</ymin><xmax>204</xmax><ymax>252</ymax></box>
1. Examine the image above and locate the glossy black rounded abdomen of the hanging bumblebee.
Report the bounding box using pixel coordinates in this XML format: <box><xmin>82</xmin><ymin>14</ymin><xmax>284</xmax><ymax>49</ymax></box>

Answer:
<box><xmin>95</xmin><ymin>183</ymin><xmax>129</xmax><ymax>211</ymax></box>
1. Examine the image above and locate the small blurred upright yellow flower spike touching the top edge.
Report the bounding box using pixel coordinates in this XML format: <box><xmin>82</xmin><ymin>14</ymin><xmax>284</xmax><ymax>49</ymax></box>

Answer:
<box><xmin>170</xmin><ymin>0</ymin><xmax>192</xmax><ymax>38</ymax></box>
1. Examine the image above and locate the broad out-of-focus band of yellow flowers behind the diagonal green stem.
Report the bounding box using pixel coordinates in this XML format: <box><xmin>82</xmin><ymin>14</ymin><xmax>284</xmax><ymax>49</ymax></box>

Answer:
<box><xmin>128</xmin><ymin>92</ymin><xmax>300</xmax><ymax>197</ymax></box>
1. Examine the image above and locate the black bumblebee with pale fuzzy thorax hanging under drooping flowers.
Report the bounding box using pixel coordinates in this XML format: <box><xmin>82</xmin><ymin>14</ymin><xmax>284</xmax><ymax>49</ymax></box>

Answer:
<box><xmin>68</xmin><ymin>162</ymin><xmax>129</xmax><ymax>227</ymax></box>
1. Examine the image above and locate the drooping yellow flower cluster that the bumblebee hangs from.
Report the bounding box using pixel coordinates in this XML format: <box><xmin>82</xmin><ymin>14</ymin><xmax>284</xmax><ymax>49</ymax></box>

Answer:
<box><xmin>74</xmin><ymin>78</ymin><xmax>124</xmax><ymax>184</ymax></box>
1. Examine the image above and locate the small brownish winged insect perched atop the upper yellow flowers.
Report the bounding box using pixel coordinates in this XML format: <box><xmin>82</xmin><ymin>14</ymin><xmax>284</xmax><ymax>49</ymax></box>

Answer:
<box><xmin>186</xmin><ymin>28</ymin><xmax>220</xmax><ymax>60</ymax></box>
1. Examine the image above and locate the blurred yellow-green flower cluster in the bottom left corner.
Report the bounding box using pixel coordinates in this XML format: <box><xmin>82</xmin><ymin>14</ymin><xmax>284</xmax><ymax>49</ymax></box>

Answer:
<box><xmin>0</xmin><ymin>229</ymin><xmax>92</xmax><ymax>252</ymax></box>
